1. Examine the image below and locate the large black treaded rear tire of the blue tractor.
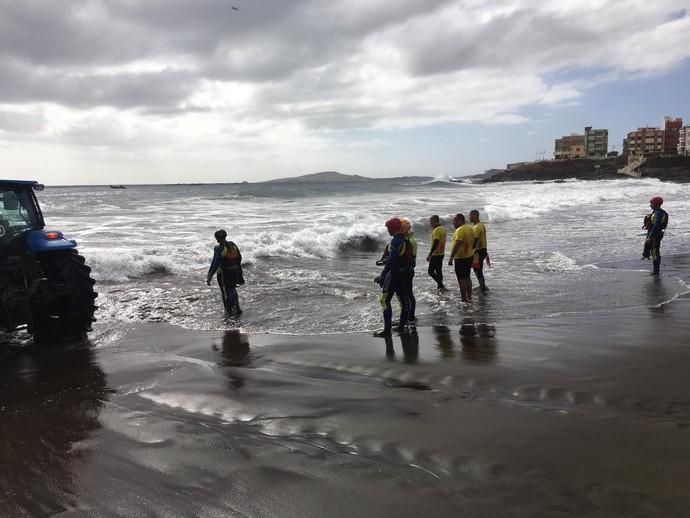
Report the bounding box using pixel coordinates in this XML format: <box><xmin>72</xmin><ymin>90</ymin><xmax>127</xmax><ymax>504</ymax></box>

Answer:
<box><xmin>29</xmin><ymin>250</ymin><xmax>98</xmax><ymax>344</ymax></box>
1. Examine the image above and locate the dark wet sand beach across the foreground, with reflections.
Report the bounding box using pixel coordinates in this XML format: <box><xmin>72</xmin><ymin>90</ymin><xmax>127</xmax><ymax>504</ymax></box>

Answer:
<box><xmin>0</xmin><ymin>294</ymin><xmax>690</xmax><ymax>518</ymax></box>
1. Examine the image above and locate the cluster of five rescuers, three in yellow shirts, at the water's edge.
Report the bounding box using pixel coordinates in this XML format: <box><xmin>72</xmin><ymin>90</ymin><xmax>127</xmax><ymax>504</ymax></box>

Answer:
<box><xmin>374</xmin><ymin>210</ymin><xmax>491</xmax><ymax>337</ymax></box>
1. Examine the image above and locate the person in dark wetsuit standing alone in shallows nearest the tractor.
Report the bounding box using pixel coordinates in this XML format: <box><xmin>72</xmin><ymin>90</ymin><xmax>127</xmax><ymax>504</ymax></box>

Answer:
<box><xmin>206</xmin><ymin>230</ymin><xmax>244</xmax><ymax>316</ymax></box>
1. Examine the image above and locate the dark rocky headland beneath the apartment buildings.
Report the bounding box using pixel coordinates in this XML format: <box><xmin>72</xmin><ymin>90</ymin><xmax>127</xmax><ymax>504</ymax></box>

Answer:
<box><xmin>477</xmin><ymin>157</ymin><xmax>690</xmax><ymax>183</ymax></box>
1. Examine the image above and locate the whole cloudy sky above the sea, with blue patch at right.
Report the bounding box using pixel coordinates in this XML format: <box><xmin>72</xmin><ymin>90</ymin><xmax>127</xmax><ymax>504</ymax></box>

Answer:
<box><xmin>0</xmin><ymin>0</ymin><xmax>690</xmax><ymax>184</ymax></box>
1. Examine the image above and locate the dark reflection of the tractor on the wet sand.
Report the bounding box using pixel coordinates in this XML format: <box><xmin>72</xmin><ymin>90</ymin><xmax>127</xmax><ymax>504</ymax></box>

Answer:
<box><xmin>0</xmin><ymin>346</ymin><xmax>108</xmax><ymax>516</ymax></box>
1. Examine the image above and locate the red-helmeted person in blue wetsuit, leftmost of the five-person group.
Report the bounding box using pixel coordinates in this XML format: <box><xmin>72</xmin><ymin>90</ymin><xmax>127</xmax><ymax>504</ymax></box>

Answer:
<box><xmin>374</xmin><ymin>218</ymin><xmax>412</xmax><ymax>337</ymax></box>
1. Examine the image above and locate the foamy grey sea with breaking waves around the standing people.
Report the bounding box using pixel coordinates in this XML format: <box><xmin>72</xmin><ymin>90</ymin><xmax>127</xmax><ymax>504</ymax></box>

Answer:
<box><xmin>39</xmin><ymin>179</ymin><xmax>690</xmax><ymax>335</ymax></box>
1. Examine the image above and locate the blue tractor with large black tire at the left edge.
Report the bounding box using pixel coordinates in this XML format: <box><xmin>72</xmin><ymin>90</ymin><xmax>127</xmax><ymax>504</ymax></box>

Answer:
<box><xmin>0</xmin><ymin>180</ymin><xmax>98</xmax><ymax>343</ymax></box>
